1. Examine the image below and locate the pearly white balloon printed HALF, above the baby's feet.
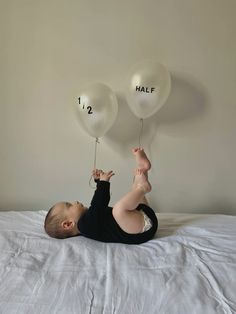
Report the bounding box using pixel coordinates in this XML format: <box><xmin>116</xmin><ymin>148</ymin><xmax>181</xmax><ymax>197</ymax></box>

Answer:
<box><xmin>126</xmin><ymin>61</ymin><xmax>171</xmax><ymax>119</ymax></box>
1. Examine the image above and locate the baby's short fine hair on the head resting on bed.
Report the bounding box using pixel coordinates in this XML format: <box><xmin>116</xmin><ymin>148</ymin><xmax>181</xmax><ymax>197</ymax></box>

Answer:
<box><xmin>44</xmin><ymin>205</ymin><xmax>73</xmax><ymax>239</ymax></box>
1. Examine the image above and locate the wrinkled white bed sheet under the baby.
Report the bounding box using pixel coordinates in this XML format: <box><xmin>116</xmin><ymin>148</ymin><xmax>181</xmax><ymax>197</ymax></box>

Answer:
<box><xmin>0</xmin><ymin>211</ymin><xmax>236</xmax><ymax>314</ymax></box>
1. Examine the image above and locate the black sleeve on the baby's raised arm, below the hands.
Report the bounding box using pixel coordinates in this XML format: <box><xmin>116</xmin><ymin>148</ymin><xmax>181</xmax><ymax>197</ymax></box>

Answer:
<box><xmin>90</xmin><ymin>180</ymin><xmax>110</xmax><ymax>209</ymax></box>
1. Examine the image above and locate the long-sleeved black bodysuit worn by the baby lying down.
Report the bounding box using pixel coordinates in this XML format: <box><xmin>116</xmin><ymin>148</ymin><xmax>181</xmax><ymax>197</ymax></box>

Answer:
<box><xmin>77</xmin><ymin>180</ymin><xmax>158</xmax><ymax>244</ymax></box>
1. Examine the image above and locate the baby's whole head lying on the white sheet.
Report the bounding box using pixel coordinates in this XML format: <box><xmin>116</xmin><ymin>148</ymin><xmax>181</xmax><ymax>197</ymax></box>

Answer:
<box><xmin>44</xmin><ymin>201</ymin><xmax>87</xmax><ymax>239</ymax></box>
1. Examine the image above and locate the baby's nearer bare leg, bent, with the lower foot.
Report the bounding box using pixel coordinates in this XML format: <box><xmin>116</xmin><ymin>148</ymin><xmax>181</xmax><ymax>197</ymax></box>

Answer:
<box><xmin>112</xmin><ymin>169</ymin><xmax>151</xmax><ymax>233</ymax></box>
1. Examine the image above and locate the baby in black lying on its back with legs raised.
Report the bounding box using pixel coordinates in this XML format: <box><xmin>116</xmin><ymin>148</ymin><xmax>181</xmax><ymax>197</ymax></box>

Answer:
<box><xmin>44</xmin><ymin>148</ymin><xmax>158</xmax><ymax>244</ymax></box>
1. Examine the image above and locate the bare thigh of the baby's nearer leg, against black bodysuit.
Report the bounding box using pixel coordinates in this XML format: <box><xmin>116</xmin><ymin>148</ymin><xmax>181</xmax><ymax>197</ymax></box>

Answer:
<box><xmin>112</xmin><ymin>206</ymin><xmax>144</xmax><ymax>233</ymax></box>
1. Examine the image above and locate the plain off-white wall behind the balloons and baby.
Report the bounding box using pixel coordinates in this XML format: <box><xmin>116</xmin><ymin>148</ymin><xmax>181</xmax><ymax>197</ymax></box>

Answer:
<box><xmin>0</xmin><ymin>0</ymin><xmax>236</xmax><ymax>214</ymax></box>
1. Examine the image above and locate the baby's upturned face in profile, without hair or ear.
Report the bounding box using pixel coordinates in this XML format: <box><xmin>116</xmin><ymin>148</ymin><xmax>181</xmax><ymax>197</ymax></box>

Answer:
<box><xmin>54</xmin><ymin>201</ymin><xmax>87</xmax><ymax>221</ymax></box>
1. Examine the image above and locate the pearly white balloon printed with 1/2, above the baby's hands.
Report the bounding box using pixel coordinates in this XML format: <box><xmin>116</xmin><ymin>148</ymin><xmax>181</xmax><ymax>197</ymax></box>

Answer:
<box><xmin>76</xmin><ymin>83</ymin><xmax>118</xmax><ymax>138</ymax></box>
